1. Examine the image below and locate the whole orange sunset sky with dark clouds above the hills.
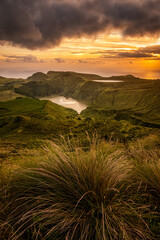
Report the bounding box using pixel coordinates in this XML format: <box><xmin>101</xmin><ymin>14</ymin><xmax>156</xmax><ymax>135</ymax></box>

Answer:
<box><xmin>0</xmin><ymin>0</ymin><xmax>160</xmax><ymax>78</ymax></box>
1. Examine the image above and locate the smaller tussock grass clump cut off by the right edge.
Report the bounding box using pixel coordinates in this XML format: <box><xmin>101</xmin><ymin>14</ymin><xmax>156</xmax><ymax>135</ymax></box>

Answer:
<box><xmin>129</xmin><ymin>135</ymin><xmax>160</xmax><ymax>198</ymax></box>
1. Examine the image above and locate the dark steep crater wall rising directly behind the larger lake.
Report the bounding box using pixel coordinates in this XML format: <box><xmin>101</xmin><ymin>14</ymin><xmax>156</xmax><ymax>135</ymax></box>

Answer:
<box><xmin>15</xmin><ymin>72</ymin><xmax>85</xmax><ymax>97</ymax></box>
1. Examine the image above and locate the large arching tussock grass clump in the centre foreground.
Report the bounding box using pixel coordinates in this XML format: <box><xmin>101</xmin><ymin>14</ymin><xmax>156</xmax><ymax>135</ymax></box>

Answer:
<box><xmin>1</xmin><ymin>140</ymin><xmax>150</xmax><ymax>240</ymax></box>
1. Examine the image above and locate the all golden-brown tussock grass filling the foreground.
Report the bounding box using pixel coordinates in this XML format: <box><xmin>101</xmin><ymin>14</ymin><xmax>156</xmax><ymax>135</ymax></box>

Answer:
<box><xmin>0</xmin><ymin>135</ymin><xmax>160</xmax><ymax>240</ymax></box>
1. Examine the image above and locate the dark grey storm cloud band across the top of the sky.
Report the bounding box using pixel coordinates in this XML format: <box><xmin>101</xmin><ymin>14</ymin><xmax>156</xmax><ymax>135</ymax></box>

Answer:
<box><xmin>0</xmin><ymin>0</ymin><xmax>160</xmax><ymax>49</ymax></box>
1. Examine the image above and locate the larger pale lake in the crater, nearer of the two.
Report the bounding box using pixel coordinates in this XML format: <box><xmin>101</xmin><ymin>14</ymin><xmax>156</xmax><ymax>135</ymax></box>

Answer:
<box><xmin>43</xmin><ymin>95</ymin><xmax>88</xmax><ymax>114</ymax></box>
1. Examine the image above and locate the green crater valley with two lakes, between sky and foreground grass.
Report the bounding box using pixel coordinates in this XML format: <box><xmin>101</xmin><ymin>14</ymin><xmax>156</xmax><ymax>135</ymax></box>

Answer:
<box><xmin>0</xmin><ymin>71</ymin><xmax>160</xmax><ymax>160</ymax></box>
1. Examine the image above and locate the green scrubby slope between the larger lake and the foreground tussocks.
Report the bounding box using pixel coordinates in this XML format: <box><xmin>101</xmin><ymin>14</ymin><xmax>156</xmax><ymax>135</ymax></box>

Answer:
<box><xmin>0</xmin><ymin>98</ymin><xmax>157</xmax><ymax>166</ymax></box>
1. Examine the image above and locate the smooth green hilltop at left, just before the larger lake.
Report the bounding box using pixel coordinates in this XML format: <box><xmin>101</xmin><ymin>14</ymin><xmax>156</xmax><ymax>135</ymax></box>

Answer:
<box><xmin>0</xmin><ymin>98</ymin><xmax>77</xmax><ymax>120</ymax></box>
